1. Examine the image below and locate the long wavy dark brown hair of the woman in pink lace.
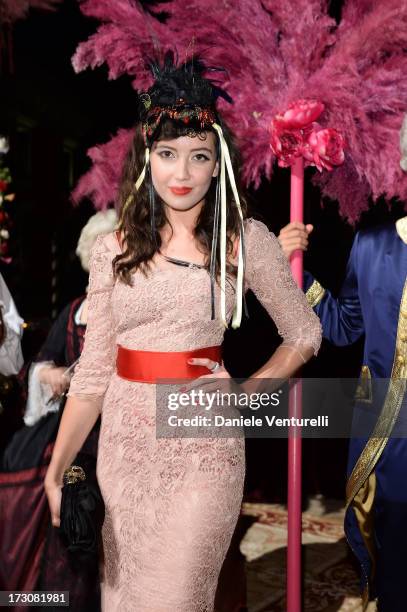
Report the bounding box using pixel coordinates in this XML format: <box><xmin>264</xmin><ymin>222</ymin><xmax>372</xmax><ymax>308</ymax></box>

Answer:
<box><xmin>113</xmin><ymin>117</ymin><xmax>247</xmax><ymax>285</ymax></box>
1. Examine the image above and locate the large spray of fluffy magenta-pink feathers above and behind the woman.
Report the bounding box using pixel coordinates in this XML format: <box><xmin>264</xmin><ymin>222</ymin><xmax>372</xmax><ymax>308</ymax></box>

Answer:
<box><xmin>73</xmin><ymin>0</ymin><xmax>407</xmax><ymax>222</ymax></box>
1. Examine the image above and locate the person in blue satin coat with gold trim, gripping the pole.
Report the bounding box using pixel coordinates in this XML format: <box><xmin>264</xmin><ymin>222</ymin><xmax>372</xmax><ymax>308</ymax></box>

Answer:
<box><xmin>279</xmin><ymin>119</ymin><xmax>407</xmax><ymax>612</ymax></box>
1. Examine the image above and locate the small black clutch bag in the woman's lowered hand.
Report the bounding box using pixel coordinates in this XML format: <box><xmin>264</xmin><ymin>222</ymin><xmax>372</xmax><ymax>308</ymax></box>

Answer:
<box><xmin>59</xmin><ymin>465</ymin><xmax>105</xmax><ymax>559</ymax></box>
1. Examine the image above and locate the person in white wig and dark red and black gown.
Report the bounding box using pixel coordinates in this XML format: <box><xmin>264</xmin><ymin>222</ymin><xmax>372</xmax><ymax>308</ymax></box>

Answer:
<box><xmin>0</xmin><ymin>210</ymin><xmax>117</xmax><ymax>611</ymax></box>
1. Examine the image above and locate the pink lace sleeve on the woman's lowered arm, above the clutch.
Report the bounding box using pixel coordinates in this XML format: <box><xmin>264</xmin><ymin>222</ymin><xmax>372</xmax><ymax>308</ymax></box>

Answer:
<box><xmin>68</xmin><ymin>236</ymin><xmax>116</xmax><ymax>403</ymax></box>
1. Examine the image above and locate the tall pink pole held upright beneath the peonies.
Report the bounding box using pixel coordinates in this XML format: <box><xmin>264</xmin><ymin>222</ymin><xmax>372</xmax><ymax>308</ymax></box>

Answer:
<box><xmin>287</xmin><ymin>157</ymin><xmax>304</xmax><ymax>612</ymax></box>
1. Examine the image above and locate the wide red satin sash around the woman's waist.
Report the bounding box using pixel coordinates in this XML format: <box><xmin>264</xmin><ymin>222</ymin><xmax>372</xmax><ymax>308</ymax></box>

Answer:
<box><xmin>116</xmin><ymin>345</ymin><xmax>221</xmax><ymax>383</ymax></box>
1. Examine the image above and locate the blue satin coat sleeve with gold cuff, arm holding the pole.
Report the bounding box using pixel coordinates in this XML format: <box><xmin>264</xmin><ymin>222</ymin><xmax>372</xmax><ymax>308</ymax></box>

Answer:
<box><xmin>304</xmin><ymin>234</ymin><xmax>364</xmax><ymax>346</ymax></box>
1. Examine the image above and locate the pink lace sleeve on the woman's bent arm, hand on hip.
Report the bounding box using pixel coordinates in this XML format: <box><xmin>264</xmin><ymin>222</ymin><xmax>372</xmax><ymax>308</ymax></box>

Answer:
<box><xmin>245</xmin><ymin>219</ymin><xmax>322</xmax><ymax>355</ymax></box>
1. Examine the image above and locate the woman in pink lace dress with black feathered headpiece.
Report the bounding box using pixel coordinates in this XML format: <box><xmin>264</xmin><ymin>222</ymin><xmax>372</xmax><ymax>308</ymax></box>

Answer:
<box><xmin>46</xmin><ymin>57</ymin><xmax>321</xmax><ymax>612</ymax></box>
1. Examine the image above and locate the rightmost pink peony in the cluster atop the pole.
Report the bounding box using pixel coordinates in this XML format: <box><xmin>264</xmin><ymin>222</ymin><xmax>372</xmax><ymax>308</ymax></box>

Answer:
<box><xmin>304</xmin><ymin>128</ymin><xmax>345</xmax><ymax>172</ymax></box>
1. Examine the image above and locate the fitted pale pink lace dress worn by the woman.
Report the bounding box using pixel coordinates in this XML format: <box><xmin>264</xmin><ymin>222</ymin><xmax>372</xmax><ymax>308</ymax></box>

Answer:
<box><xmin>69</xmin><ymin>219</ymin><xmax>321</xmax><ymax>612</ymax></box>
